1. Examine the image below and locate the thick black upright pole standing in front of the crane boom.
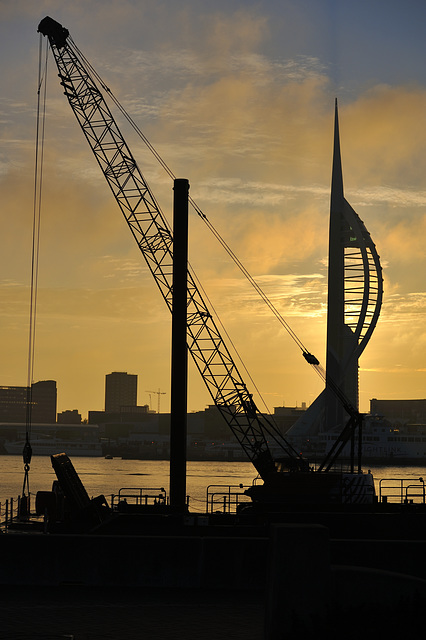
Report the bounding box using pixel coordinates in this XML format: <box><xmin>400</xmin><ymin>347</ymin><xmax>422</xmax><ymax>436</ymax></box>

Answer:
<box><xmin>170</xmin><ymin>178</ymin><xmax>189</xmax><ymax>513</ymax></box>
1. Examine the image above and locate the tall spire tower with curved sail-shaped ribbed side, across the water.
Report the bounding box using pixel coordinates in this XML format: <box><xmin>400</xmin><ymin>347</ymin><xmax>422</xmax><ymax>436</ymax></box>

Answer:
<box><xmin>289</xmin><ymin>100</ymin><xmax>383</xmax><ymax>436</ymax></box>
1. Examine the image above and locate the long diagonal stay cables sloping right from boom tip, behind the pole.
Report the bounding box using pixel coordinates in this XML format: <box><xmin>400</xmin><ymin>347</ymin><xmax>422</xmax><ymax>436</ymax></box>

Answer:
<box><xmin>68</xmin><ymin>36</ymin><xmax>326</xmax><ymax>381</ymax></box>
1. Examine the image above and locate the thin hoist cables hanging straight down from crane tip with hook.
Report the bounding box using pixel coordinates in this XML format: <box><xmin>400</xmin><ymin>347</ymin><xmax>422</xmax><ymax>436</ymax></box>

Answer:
<box><xmin>21</xmin><ymin>34</ymin><xmax>48</xmax><ymax>514</ymax></box>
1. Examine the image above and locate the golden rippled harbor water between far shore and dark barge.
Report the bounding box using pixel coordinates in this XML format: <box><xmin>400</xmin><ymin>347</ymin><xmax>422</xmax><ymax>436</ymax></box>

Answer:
<box><xmin>0</xmin><ymin>455</ymin><xmax>426</xmax><ymax>513</ymax></box>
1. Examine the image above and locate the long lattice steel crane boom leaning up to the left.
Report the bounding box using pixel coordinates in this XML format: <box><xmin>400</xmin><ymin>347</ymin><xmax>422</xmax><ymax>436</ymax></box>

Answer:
<box><xmin>38</xmin><ymin>17</ymin><xmax>300</xmax><ymax>478</ymax></box>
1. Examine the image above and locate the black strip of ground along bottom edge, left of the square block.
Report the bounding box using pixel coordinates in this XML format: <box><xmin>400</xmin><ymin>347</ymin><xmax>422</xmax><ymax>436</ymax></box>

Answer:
<box><xmin>0</xmin><ymin>586</ymin><xmax>264</xmax><ymax>640</ymax></box>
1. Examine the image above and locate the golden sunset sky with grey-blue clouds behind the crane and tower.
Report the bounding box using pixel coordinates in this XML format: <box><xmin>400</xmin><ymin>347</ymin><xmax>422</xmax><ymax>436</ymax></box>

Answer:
<box><xmin>0</xmin><ymin>0</ymin><xmax>426</xmax><ymax>417</ymax></box>
